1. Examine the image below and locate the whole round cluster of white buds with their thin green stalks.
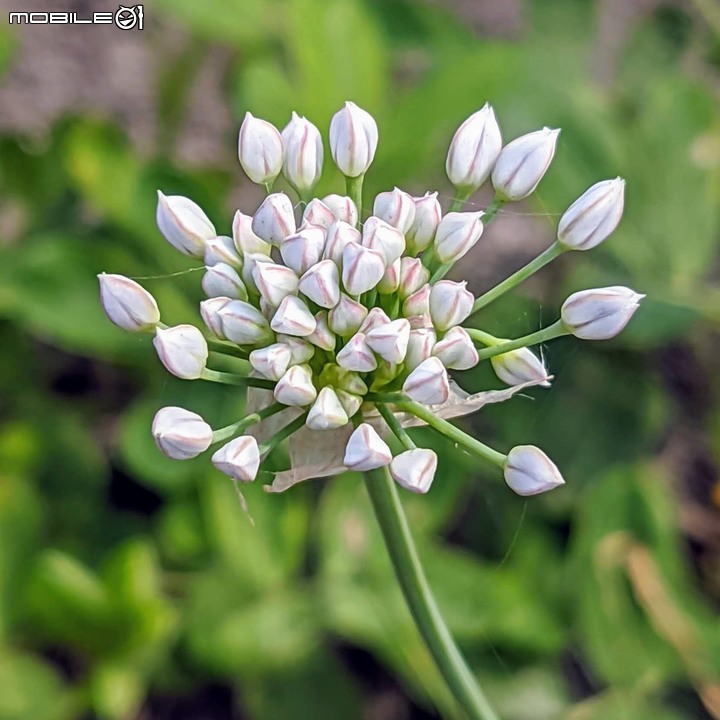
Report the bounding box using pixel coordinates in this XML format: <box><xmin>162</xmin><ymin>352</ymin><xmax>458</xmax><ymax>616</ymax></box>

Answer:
<box><xmin>99</xmin><ymin>102</ymin><xmax>641</xmax><ymax>495</ymax></box>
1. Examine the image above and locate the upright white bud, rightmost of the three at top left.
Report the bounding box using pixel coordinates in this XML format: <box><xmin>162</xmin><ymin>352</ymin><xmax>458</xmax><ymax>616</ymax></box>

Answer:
<box><xmin>330</xmin><ymin>102</ymin><xmax>378</xmax><ymax>177</ymax></box>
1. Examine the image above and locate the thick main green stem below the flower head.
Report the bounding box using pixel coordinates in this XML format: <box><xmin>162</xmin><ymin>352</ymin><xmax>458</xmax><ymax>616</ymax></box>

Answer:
<box><xmin>365</xmin><ymin>468</ymin><xmax>498</xmax><ymax>720</ymax></box>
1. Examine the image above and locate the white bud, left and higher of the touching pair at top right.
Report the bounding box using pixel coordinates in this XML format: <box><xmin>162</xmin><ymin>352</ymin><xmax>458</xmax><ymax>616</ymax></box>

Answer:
<box><xmin>445</xmin><ymin>103</ymin><xmax>502</xmax><ymax>192</ymax></box>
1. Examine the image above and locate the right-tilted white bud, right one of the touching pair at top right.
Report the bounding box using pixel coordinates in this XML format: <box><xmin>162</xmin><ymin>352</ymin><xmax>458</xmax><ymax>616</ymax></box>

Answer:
<box><xmin>492</xmin><ymin>128</ymin><xmax>560</xmax><ymax>200</ymax></box>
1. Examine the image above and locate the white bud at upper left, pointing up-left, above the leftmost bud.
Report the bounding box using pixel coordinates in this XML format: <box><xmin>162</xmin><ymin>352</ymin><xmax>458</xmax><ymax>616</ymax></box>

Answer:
<box><xmin>155</xmin><ymin>190</ymin><xmax>217</xmax><ymax>260</ymax></box>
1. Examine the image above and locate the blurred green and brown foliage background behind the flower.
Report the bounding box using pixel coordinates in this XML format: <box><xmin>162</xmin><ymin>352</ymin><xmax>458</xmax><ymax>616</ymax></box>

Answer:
<box><xmin>0</xmin><ymin>0</ymin><xmax>720</xmax><ymax>720</ymax></box>
